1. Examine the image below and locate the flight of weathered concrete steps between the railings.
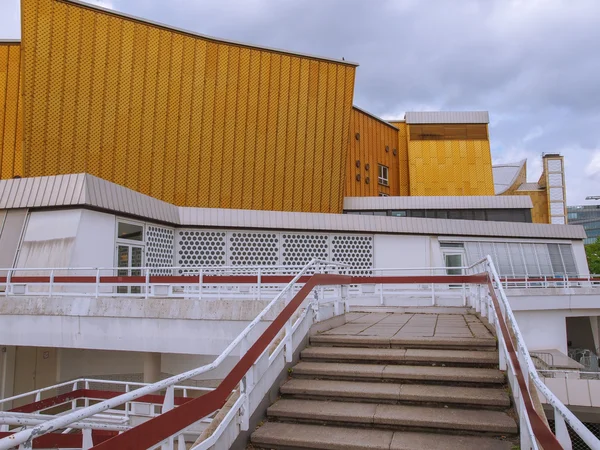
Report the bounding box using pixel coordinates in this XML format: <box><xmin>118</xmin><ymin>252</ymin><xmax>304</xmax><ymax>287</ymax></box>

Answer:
<box><xmin>251</xmin><ymin>312</ymin><xmax>518</xmax><ymax>450</ymax></box>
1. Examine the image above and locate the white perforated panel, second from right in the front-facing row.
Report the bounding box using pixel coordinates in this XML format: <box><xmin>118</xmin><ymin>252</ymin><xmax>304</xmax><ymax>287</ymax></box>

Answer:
<box><xmin>281</xmin><ymin>234</ymin><xmax>329</xmax><ymax>266</ymax></box>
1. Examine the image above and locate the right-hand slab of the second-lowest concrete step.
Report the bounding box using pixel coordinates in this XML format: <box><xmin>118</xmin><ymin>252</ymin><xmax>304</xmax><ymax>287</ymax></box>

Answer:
<box><xmin>372</xmin><ymin>402</ymin><xmax>517</xmax><ymax>434</ymax></box>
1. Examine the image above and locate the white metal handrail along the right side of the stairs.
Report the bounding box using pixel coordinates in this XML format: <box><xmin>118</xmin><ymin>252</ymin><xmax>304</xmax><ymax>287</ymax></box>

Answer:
<box><xmin>479</xmin><ymin>255</ymin><xmax>600</xmax><ymax>449</ymax></box>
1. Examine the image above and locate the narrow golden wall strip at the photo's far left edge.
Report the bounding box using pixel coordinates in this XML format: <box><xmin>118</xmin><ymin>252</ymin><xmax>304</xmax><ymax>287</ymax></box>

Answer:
<box><xmin>0</xmin><ymin>42</ymin><xmax>23</xmax><ymax>178</ymax></box>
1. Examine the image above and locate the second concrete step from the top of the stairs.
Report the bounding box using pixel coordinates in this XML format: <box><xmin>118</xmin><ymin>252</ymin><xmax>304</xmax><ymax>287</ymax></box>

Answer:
<box><xmin>301</xmin><ymin>347</ymin><xmax>498</xmax><ymax>366</ymax></box>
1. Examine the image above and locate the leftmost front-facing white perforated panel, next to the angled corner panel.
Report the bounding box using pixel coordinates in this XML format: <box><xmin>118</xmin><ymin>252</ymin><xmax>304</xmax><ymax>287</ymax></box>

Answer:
<box><xmin>176</xmin><ymin>230</ymin><xmax>226</xmax><ymax>267</ymax></box>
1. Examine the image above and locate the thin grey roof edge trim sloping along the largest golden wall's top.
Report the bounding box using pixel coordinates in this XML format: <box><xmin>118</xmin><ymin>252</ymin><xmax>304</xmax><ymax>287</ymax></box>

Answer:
<box><xmin>62</xmin><ymin>0</ymin><xmax>359</xmax><ymax>67</ymax></box>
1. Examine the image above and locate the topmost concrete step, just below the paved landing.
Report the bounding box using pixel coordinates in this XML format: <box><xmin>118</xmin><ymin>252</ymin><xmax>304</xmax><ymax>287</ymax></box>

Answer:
<box><xmin>310</xmin><ymin>334</ymin><xmax>496</xmax><ymax>351</ymax></box>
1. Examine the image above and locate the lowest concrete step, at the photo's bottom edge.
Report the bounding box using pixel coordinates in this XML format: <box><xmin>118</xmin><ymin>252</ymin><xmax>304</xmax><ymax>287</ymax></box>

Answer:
<box><xmin>252</xmin><ymin>422</ymin><xmax>512</xmax><ymax>450</ymax></box>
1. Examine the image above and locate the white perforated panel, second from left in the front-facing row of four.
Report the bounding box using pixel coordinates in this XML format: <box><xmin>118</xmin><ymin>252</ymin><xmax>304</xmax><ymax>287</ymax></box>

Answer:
<box><xmin>227</xmin><ymin>232</ymin><xmax>279</xmax><ymax>266</ymax></box>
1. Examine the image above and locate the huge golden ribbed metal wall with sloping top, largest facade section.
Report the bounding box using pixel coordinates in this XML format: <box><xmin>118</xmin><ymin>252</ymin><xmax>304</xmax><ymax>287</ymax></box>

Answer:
<box><xmin>21</xmin><ymin>0</ymin><xmax>355</xmax><ymax>212</ymax></box>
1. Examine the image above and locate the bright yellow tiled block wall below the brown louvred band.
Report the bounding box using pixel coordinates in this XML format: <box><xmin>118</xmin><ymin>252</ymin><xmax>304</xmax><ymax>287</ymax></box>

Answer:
<box><xmin>408</xmin><ymin>125</ymin><xmax>494</xmax><ymax>196</ymax></box>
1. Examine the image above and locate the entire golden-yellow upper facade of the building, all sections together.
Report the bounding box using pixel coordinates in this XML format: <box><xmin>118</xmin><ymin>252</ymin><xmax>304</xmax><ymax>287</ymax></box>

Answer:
<box><xmin>0</xmin><ymin>0</ymin><xmax>564</xmax><ymax>223</ymax></box>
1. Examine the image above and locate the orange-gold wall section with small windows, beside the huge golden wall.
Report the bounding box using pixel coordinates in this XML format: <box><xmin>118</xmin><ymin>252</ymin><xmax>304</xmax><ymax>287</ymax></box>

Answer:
<box><xmin>345</xmin><ymin>108</ymin><xmax>400</xmax><ymax>197</ymax></box>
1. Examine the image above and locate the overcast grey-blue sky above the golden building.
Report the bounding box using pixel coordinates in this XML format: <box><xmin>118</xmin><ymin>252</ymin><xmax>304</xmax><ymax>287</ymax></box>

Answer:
<box><xmin>0</xmin><ymin>0</ymin><xmax>600</xmax><ymax>204</ymax></box>
